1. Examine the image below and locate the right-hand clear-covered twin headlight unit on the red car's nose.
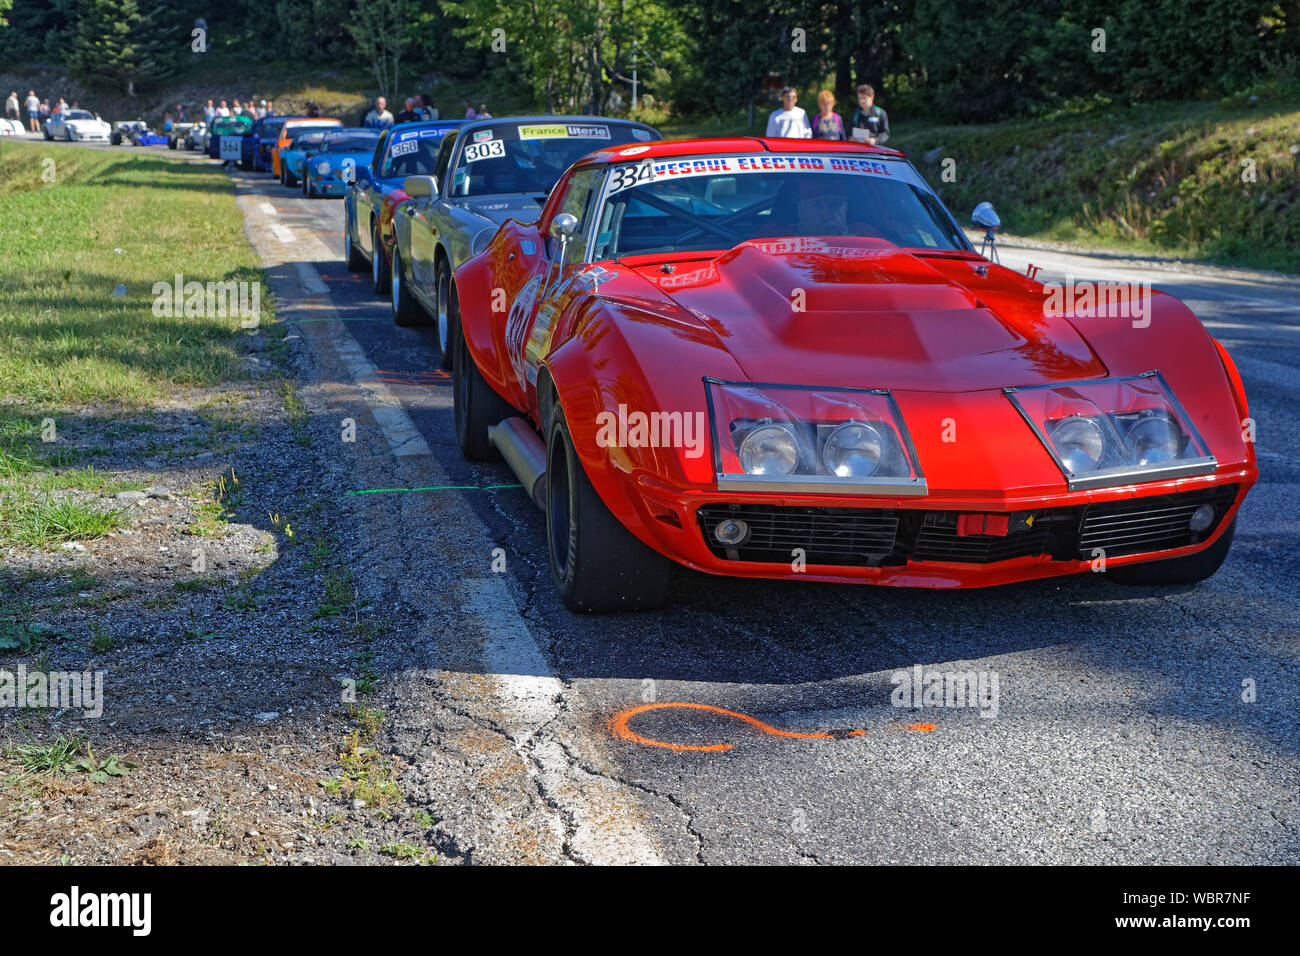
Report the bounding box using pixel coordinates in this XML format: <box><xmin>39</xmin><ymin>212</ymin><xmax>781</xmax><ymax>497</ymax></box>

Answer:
<box><xmin>1002</xmin><ymin>371</ymin><xmax>1218</xmax><ymax>492</ymax></box>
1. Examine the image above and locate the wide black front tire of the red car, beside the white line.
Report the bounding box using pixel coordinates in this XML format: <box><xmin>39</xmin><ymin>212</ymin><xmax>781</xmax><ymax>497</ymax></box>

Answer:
<box><xmin>546</xmin><ymin>402</ymin><xmax>671</xmax><ymax>614</ymax></box>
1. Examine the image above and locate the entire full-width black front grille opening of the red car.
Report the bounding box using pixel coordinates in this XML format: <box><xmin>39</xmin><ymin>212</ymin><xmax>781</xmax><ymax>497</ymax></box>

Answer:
<box><xmin>698</xmin><ymin>485</ymin><xmax>1238</xmax><ymax>567</ymax></box>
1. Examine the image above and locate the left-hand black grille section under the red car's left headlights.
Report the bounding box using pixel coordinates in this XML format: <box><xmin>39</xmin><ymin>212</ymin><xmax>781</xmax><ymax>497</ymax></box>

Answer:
<box><xmin>699</xmin><ymin>505</ymin><xmax>898</xmax><ymax>564</ymax></box>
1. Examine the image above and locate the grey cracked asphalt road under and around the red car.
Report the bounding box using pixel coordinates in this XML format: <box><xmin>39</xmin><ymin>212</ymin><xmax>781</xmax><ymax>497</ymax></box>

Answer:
<box><xmin>63</xmin><ymin>136</ymin><xmax>1300</xmax><ymax>864</ymax></box>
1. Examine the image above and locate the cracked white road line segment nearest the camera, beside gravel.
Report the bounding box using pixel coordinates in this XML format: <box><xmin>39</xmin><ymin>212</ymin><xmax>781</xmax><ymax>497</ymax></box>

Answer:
<box><xmin>463</xmin><ymin>574</ymin><xmax>663</xmax><ymax>865</ymax></box>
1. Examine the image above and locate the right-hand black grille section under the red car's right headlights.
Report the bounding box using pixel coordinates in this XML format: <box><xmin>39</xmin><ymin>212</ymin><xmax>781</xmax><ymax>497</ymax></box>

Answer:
<box><xmin>1079</xmin><ymin>485</ymin><xmax>1236</xmax><ymax>558</ymax></box>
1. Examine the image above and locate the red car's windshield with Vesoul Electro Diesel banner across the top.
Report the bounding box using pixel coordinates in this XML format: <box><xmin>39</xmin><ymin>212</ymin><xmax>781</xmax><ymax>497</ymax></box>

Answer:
<box><xmin>595</xmin><ymin>153</ymin><xmax>969</xmax><ymax>259</ymax></box>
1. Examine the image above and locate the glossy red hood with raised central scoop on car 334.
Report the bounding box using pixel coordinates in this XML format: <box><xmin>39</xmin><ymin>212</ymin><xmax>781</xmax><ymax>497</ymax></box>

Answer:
<box><xmin>642</xmin><ymin>239</ymin><xmax>1106</xmax><ymax>392</ymax></box>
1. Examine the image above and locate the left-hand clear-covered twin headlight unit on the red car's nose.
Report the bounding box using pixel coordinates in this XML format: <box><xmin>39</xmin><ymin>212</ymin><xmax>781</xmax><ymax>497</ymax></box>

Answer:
<box><xmin>705</xmin><ymin>378</ymin><xmax>926</xmax><ymax>494</ymax></box>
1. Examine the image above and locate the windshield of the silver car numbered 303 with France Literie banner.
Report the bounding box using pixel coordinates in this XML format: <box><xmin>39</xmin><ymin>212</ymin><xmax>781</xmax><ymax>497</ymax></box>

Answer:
<box><xmin>451</xmin><ymin>122</ymin><xmax>659</xmax><ymax>196</ymax></box>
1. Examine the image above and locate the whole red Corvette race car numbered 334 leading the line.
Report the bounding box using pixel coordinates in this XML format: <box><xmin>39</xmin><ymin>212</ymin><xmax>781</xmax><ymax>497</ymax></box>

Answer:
<box><xmin>451</xmin><ymin>138</ymin><xmax>1258</xmax><ymax>610</ymax></box>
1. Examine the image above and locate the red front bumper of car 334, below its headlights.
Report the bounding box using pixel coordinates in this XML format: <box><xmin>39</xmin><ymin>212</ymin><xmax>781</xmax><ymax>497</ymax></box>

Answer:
<box><xmin>629</xmin><ymin>467</ymin><xmax>1257</xmax><ymax>588</ymax></box>
